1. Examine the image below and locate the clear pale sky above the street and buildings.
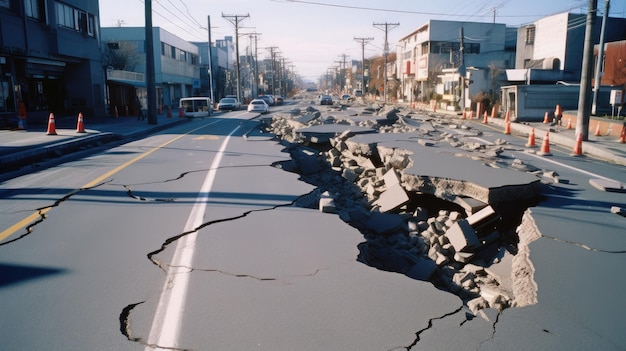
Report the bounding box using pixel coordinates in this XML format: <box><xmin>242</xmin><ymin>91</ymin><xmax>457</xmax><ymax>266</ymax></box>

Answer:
<box><xmin>100</xmin><ymin>0</ymin><xmax>626</xmax><ymax>80</ymax></box>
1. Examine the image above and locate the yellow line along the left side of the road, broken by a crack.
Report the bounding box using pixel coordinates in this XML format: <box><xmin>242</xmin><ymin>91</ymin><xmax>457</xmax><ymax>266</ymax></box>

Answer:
<box><xmin>0</xmin><ymin>121</ymin><xmax>219</xmax><ymax>241</ymax></box>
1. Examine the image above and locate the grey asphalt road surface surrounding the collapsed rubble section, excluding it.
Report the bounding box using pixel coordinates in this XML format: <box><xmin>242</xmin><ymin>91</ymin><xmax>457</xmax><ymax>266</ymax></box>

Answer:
<box><xmin>0</xmin><ymin>99</ymin><xmax>626</xmax><ymax>350</ymax></box>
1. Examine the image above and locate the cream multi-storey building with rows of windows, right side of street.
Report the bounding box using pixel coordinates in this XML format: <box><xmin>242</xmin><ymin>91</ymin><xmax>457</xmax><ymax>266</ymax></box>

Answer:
<box><xmin>396</xmin><ymin>20</ymin><xmax>515</xmax><ymax>109</ymax></box>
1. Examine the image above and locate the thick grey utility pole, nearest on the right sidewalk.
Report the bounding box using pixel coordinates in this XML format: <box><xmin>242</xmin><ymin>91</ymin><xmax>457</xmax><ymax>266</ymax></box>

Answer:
<box><xmin>576</xmin><ymin>0</ymin><xmax>598</xmax><ymax>140</ymax></box>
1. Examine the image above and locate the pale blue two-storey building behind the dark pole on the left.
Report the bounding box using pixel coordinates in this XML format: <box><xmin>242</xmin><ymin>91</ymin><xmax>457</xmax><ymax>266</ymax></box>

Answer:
<box><xmin>102</xmin><ymin>27</ymin><xmax>201</xmax><ymax>114</ymax></box>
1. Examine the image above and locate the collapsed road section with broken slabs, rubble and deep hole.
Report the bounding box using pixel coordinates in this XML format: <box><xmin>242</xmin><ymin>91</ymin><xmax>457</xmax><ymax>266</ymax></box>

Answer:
<box><xmin>264</xmin><ymin>100</ymin><xmax>541</xmax><ymax>314</ymax></box>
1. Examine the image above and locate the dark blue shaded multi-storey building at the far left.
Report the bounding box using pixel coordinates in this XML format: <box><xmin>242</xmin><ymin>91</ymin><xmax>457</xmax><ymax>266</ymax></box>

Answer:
<box><xmin>0</xmin><ymin>0</ymin><xmax>105</xmax><ymax>125</ymax></box>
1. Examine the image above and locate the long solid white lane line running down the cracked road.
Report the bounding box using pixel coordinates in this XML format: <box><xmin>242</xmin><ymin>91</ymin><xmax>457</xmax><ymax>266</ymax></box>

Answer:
<box><xmin>145</xmin><ymin>126</ymin><xmax>239</xmax><ymax>351</ymax></box>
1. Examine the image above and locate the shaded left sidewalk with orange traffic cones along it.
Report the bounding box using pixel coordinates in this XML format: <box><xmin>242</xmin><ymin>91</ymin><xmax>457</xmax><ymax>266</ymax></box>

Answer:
<box><xmin>0</xmin><ymin>114</ymin><xmax>187</xmax><ymax>173</ymax></box>
